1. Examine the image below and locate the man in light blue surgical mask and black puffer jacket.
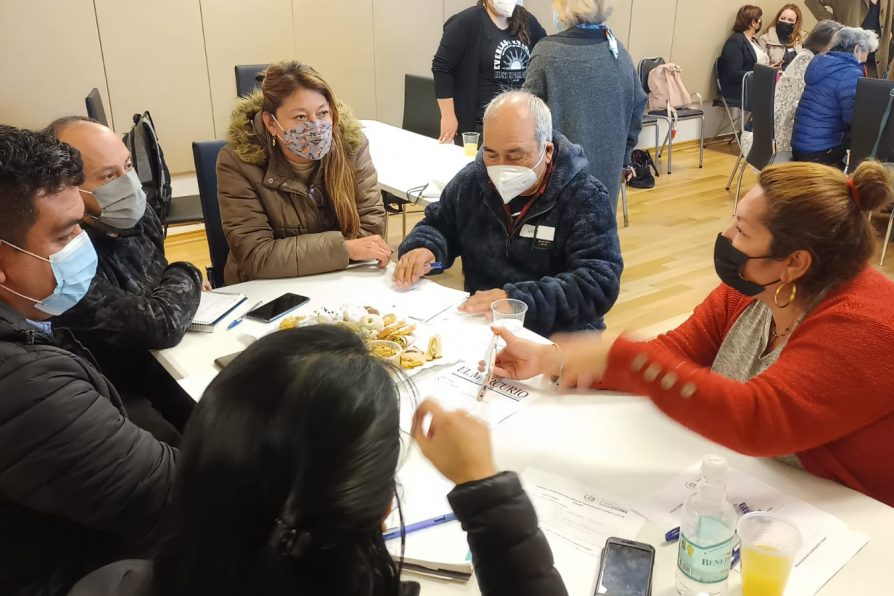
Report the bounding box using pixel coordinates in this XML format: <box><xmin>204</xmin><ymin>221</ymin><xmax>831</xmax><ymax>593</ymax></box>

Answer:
<box><xmin>0</xmin><ymin>126</ymin><xmax>176</xmax><ymax>595</ymax></box>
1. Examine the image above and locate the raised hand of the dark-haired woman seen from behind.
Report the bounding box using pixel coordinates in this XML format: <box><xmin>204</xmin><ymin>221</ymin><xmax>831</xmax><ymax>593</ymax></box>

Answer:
<box><xmin>411</xmin><ymin>399</ymin><xmax>497</xmax><ymax>484</ymax></box>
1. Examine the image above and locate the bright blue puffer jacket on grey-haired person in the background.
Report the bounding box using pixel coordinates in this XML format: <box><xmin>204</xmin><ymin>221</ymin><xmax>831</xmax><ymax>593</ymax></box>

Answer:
<box><xmin>792</xmin><ymin>52</ymin><xmax>864</xmax><ymax>153</ymax></box>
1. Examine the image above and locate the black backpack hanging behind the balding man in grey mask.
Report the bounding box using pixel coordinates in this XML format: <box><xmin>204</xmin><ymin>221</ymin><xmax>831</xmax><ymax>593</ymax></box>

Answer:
<box><xmin>123</xmin><ymin>112</ymin><xmax>171</xmax><ymax>225</ymax></box>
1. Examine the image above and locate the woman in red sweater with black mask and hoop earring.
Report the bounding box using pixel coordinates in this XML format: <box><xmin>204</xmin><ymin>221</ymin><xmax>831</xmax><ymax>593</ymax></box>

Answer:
<box><xmin>496</xmin><ymin>162</ymin><xmax>894</xmax><ymax>506</ymax></box>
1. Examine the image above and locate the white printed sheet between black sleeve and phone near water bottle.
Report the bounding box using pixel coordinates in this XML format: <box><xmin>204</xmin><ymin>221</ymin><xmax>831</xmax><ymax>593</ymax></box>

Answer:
<box><xmin>521</xmin><ymin>469</ymin><xmax>645</xmax><ymax>596</ymax></box>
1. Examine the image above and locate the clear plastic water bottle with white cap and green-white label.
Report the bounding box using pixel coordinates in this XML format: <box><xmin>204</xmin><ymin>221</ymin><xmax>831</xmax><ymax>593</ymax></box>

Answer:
<box><xmin>676</xmin><ymin>455</ymin><xmax>738</xmax><ymax>596</ymax></box>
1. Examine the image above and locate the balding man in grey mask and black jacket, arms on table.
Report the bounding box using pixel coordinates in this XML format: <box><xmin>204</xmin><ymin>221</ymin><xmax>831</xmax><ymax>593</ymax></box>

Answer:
<box><xmin>47</xmin><ymin>116</ymin><xmax>202</xmax><ymax>444</ymax></box>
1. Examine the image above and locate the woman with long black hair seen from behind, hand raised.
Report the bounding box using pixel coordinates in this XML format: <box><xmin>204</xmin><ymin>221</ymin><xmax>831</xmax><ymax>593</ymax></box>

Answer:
<box><xmin>70</xmin><ymin>326</ymin><xmax>566</xmax><ymax>596</ymax></box>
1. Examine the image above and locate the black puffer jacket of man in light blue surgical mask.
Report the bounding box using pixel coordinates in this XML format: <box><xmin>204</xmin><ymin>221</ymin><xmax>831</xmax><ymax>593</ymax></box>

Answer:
<box><xmin>0</xmin><ymin>303</ymin><xmax>176</xmax><ymax>596</ymax></box>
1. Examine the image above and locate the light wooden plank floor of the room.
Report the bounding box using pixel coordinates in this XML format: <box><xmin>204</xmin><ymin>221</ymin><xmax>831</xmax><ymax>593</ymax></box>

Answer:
<box><xmin>166</xmin><ymin>143</ymin><xmax>894</xmax><ymax>335</ymax></box>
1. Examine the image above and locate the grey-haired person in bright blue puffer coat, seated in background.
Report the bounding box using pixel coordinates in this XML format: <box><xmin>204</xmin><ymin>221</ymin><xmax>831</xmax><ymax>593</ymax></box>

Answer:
<box><xmin>792</xmin><ymin>27</ymin><xmax>878</xmax><ymax>168</ymax></box>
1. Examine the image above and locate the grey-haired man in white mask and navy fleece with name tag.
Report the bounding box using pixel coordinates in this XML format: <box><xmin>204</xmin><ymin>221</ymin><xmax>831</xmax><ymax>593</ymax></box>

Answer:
<box><xmin>394</xmin><ymin>91</ymin><xmax>623</xmax><ymax>335</ymax></box>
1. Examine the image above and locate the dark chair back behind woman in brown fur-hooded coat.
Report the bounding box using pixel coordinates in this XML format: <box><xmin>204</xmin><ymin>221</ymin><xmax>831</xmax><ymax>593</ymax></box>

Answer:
<box><xmin>192</xmin><ymin>141</ymin><xmax>230</xmax><ymax>288</ymax></box>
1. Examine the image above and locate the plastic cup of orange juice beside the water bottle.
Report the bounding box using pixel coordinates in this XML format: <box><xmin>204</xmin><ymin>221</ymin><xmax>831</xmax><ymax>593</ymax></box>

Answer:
<box><xmin>737</xmin><ymin>511</ymin><xmax>801</xmax><ymax>596</ymax></box>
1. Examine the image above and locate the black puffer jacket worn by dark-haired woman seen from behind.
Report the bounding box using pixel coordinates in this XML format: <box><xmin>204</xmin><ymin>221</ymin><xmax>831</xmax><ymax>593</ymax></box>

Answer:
<box><xmin>68</xmin><ymin>472</ymin><xmax>568</xmax><ymax>596</ymax></box>
